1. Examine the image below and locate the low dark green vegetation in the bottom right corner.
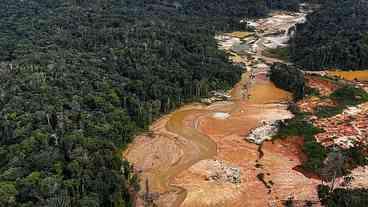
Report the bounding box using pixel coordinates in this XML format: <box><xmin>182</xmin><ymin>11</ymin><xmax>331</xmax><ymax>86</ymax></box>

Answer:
<box><xmin>318</xmin><ymin>185</ymin><xmax>368</xmax><ymax>207</ymax></box>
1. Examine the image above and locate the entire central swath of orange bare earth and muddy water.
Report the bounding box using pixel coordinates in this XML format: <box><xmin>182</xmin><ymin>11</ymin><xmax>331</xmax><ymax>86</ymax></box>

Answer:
<box><xmin>123</xmin><ymin>8</ymin><xmax>320</xmax><ymax>207</ymax></box>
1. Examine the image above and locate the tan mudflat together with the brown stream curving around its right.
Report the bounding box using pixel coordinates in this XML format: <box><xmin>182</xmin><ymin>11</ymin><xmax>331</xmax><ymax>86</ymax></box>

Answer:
<box><xmin>123</xmin><ymin>105</ymin><xmax>220</xmax><ymax>206</ymax></box>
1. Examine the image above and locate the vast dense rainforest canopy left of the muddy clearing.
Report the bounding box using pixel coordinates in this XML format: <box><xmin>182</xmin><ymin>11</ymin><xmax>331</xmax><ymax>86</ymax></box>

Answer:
<box><xmin>0</xmin><ymin>0</ymin><xmax>298</xmax><ymax>207</ymax></box>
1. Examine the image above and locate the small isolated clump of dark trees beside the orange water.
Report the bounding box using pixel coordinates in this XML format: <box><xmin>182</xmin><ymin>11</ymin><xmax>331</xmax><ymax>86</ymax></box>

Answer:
<box><xmin>270</xmin><ymin>63</ymin><xmax>305</xmax><ymax>100</ymax></box>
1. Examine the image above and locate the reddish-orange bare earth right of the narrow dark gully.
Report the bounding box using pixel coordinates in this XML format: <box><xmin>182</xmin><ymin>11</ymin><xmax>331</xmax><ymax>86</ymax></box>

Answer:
<box><xmin>259</xmin><ymin>138</ymin><xmax>321</xmax><ymax>206</ymax></box>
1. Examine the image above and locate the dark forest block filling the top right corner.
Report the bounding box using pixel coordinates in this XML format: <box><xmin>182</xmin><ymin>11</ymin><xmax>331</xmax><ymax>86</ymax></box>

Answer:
<box><xmin>290</xmin><ymin>0</ymin><xmax>368</xmax><ymax>70</ymax></box>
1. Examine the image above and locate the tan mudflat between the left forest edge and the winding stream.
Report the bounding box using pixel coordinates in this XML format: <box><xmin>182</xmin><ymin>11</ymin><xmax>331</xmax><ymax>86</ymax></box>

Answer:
<box><xmin>123</xmin><ymin>116</ymin><xmax>190</xmax><ymax>203</ymax></box>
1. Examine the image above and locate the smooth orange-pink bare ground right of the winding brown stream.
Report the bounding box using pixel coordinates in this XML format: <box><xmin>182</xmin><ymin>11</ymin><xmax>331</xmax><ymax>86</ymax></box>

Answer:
<box><xmin>170</xmin><ymin>104</ymin><xmax>320</xmax><ymax>207</ymax></box>
